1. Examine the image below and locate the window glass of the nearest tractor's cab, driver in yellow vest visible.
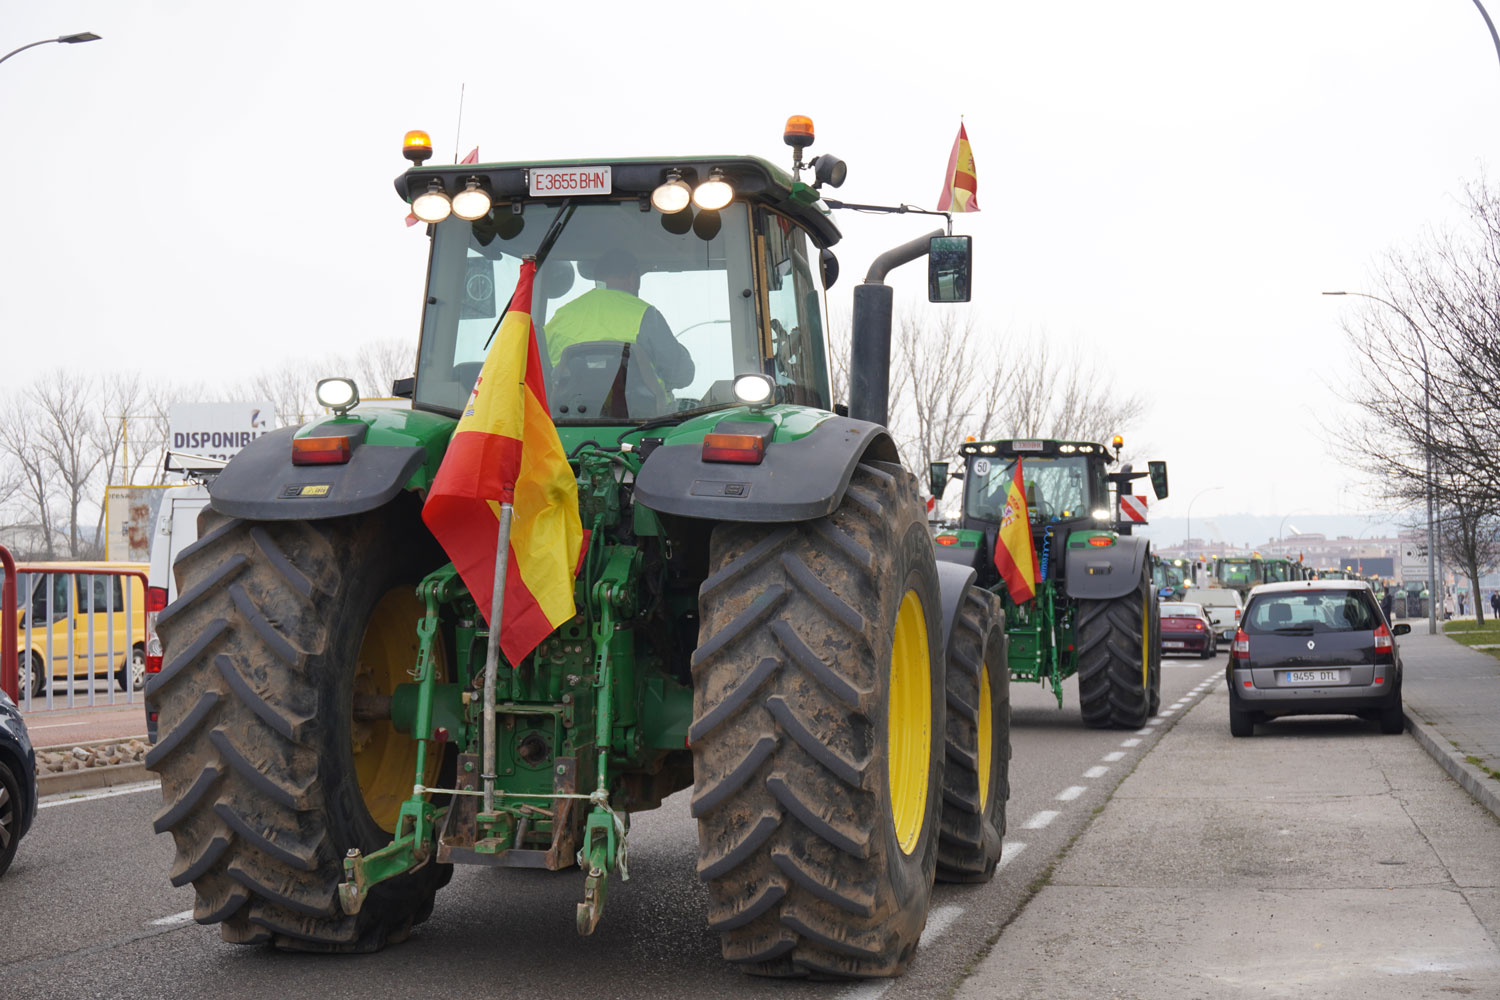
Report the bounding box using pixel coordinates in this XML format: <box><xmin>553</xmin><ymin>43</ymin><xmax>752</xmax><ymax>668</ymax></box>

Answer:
<box><xmin>414</xmin><ymin>198</ymin><xmax>830</xmax><ymax>424</ymax></box>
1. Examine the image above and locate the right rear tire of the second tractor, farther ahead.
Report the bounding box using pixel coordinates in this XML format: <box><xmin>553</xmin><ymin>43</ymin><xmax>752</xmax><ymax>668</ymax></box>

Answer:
<box><xmin>1076</xmin><ymin>571</ymin><xmax>1161</xmax><ymax>729</ymax></box>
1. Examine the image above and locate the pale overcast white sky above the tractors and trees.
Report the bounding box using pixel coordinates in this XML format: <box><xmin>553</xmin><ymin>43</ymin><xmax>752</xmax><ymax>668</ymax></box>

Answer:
<box><xmin>0</xmin><ymin>0</ymin><xmax>1500</xmax><ymax>517</ymax></box>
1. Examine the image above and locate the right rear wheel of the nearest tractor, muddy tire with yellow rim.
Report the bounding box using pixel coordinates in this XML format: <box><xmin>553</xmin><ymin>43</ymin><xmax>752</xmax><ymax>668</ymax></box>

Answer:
<box><xmin>689</xmin><ymin>462</ymin><xmax>945</xmax><ymax>978</ymax></box>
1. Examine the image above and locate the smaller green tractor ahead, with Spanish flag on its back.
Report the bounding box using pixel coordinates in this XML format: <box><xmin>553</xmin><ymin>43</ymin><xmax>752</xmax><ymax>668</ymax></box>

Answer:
<box><xmin>930</xmin><ymin>436</ymin><xmax>1167</xmax><ymax>729</ymax></box>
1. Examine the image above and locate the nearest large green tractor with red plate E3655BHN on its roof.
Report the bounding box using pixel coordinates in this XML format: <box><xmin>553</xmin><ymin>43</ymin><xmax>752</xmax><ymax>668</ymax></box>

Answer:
<box><xmin>146</xmin><ymin>118</ymin><xmax>1011</xmax><ymax>978</ymax></box>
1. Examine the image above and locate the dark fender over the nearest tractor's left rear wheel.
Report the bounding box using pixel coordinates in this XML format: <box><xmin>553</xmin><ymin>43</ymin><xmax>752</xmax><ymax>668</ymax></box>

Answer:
<box><xmin>209</xmin><ymin>424</ymin><xmax>428</xmax><ymax>520</ymax></box>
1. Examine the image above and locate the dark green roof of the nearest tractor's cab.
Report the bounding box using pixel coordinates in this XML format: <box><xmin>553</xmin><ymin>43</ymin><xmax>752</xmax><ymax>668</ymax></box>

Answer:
<box><xmin>396</xmin><ymin>154</ymin><xmax>843</xmax><ymax>247</ymax></box>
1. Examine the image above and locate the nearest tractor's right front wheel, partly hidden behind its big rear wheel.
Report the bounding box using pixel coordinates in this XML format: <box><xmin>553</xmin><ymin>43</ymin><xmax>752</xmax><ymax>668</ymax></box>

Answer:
<box><xmin>938</xmin><ymin>585</ymin><xmax>1011</xmax><ymax>882</ymax></box>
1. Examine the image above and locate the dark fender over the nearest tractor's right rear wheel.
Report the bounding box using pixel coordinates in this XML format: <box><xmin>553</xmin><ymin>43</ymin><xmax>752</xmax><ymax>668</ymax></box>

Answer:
<box><xmin>635</xmin><ymin>417</ymin><xmax>900</xmax><ymax>523</ymax></box>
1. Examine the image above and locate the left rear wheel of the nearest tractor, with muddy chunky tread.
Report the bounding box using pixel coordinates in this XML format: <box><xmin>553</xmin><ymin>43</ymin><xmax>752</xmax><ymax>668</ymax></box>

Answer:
<box><xmin>146</xmin><ymin>505</ymin><xmax>453</xmax><ymax>952</ymax></box>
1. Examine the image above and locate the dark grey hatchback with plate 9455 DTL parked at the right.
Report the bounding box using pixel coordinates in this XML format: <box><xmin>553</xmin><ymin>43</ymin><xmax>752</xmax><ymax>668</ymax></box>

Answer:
<box><xmin>1229</xmin><ymin>580</ymin><xmax>1412</xmax><ymax>736</ymax></box>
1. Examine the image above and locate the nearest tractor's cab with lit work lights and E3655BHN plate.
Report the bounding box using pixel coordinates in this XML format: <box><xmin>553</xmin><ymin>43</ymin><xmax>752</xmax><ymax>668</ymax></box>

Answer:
<box><xmin>396</xmin><ymin>138</ymin><xmax>843</xmax><ymax>435</ymax></box>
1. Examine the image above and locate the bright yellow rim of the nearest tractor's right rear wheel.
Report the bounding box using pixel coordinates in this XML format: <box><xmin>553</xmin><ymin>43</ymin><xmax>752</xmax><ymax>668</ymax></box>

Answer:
<box><xmin>887</xmin><ymin>591</ymin><xmax>933</xmax><ymax>855</ymax></box>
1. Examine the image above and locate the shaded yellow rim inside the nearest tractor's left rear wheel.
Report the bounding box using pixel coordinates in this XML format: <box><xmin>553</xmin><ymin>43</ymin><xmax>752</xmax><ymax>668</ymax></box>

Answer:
<box><xmin>351</xmin><ymin>586</ymin><xmax>447</xmax><ymax>834</ymax></box>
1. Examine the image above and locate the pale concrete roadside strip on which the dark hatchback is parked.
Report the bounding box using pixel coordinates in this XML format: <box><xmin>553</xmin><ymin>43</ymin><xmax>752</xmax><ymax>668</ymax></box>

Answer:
<box><xmin>956</xmin><ymin>677</ymin><xmax>1500</xmax><ymax>1000</ymax></box>
